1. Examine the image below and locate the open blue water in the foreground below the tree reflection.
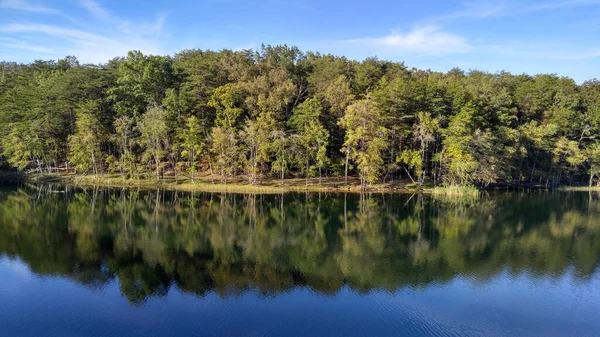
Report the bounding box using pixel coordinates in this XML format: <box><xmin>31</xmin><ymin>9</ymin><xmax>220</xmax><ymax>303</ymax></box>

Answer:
<box><xmin>0</xmin><ymin>258</ymin><xmax>600</xmax><ymax>337</ymax></box>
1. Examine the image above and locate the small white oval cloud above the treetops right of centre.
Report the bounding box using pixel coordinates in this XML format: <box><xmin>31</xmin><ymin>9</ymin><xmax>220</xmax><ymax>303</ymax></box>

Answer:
<box><xmin>347</xmin><ymin>26</ymin><xmax>471</xmax><ymax>55</ymax></box>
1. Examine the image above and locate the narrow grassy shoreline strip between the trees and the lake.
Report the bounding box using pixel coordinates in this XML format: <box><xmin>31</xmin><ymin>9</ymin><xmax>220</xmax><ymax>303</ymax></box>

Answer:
<box><xmin>5</xmin><ymin>171</ymin><xmax>600</xmax><ymax>193</ymax></box>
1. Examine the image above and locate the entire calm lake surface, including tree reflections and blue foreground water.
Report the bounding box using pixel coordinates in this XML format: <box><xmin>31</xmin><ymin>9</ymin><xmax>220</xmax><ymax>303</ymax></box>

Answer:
<box><xmin>0</xmin><ymin>186</ymin><xmax>600</xmax><ymax>337</ymax></box>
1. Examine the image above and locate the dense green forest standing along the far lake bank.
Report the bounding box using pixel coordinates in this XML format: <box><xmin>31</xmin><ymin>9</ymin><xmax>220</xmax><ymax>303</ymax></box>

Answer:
<box><xmin>0</xmin><ymin>46</ymin><xmax>600</xmax><ymax>187</ymax></box>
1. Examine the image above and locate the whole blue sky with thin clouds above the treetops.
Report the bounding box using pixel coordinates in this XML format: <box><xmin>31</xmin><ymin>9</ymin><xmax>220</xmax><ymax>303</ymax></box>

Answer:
<box><xmin>0</xmin><ymin>0</ymin><xmax>600</xmax><ymax>82</ymax></box>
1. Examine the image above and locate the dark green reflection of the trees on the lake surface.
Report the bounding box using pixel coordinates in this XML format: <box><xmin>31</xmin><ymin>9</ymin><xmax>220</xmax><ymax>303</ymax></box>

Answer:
<box><xmin>0</xmin><ymin>185</ymin><xmax>600</xmax><ymax>304</ymax></box>
